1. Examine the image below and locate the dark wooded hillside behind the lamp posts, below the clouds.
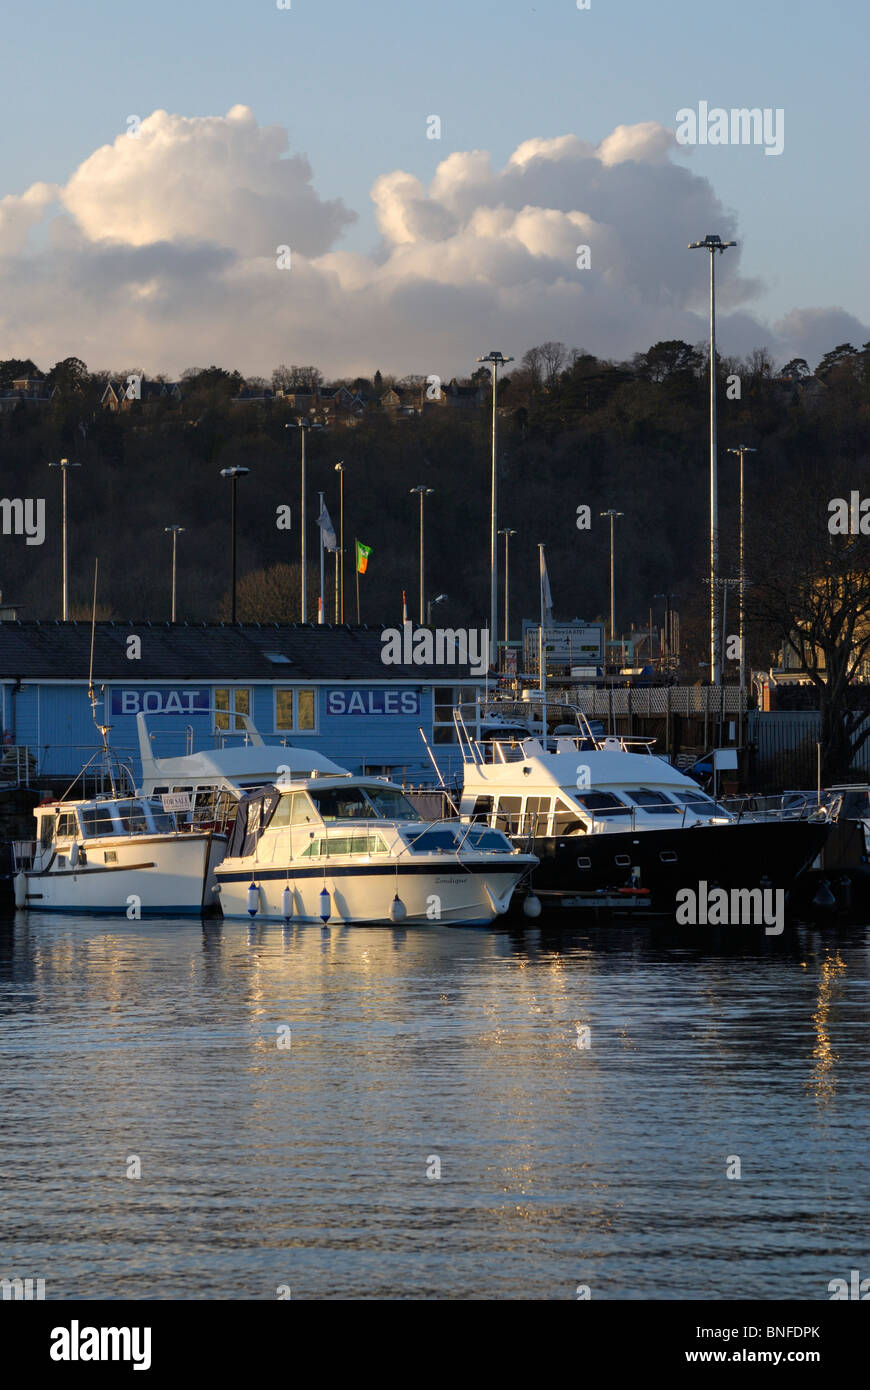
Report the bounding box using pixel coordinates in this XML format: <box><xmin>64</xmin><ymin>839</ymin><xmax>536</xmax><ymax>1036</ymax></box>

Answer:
<box><xmin>0</xmin><ymin>342</ymin><xmax>870</xmax><ymax>695</ymax></box>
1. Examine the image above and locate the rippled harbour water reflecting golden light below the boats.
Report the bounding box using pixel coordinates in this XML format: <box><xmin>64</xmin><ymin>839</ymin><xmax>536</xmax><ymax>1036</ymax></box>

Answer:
<box><xmin>0</xmin><ymin>913</ymin><xmax>870</xmax><ymax>1300</ymax></box>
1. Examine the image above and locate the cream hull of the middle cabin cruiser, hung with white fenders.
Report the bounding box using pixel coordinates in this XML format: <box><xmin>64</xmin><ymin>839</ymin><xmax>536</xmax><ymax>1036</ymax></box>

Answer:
<box><xmin>217</xmin><ymin>856</ymin><xmax>532</xmax><ymax>926</ymax></box>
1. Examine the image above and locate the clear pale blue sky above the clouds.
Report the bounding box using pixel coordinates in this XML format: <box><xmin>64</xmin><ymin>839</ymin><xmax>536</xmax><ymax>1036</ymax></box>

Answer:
<box><xmin>0</xmin><ymin>0</ymin><xmax>870</xmax><ymax>372</ymax></box>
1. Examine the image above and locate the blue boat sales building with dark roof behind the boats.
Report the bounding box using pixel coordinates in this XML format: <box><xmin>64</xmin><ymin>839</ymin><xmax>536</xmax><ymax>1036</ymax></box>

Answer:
<box><xmin>0</xmin><ymin>621</ymin><xmax>486</xmax><ymax>781</ymax></box>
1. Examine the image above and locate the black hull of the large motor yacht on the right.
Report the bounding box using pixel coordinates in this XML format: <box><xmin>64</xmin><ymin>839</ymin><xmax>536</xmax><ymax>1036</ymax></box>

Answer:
<box><xmin>514</xmin><ymin>820</ymin><xmax>831</xmax><ymax>913</ymax></box>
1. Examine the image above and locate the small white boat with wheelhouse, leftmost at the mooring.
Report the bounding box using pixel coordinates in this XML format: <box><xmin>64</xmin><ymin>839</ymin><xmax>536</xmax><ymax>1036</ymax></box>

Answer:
<box><xmin>15</xmin><ymin>796</ymin><xmax>227</xmax><ymax>917</ymax></box>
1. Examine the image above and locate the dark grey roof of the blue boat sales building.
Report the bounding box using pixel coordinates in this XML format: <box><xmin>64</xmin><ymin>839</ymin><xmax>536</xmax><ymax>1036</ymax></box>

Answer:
<box><xmin>0</xmin><ymin>620</ymin><xmax>475</xmax><ymax>685</ymax></box>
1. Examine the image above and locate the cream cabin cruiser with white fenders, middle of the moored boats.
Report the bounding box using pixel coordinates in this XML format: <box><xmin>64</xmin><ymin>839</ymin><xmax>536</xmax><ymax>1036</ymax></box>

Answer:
<box><xmin>215</xmin><ymin>773</ymin><xmax>536</xmax><ymax>926</ymax></box>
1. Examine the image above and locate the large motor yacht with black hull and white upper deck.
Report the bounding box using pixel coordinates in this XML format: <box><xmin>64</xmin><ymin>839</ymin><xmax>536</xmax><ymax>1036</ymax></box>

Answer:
<box><xmin>454</xmin><ymin>709</ymin><xmax>831</xmax><ymax>913</ymax></box>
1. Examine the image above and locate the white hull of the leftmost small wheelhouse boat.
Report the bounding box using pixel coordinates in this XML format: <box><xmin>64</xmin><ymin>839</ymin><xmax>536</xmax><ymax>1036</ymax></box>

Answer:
<box><xmin>25</xmin><ymin>834</ymin><xmax>227</xmax><ymax>919</ymax></box>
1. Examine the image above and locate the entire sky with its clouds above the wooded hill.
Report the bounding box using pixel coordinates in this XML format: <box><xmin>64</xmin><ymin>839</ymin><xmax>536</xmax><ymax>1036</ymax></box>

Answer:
<box><xmin>0</xmin><ymin>0</ymin><xmax>870</xmax><ymax>375</ymax></box>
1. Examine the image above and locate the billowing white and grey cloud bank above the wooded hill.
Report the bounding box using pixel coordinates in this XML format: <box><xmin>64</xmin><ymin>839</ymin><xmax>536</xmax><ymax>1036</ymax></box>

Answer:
<box><xmin>0</xmin><ymin>106</ymin><xmax>870</xmax><ymax>374</ymax></box>
